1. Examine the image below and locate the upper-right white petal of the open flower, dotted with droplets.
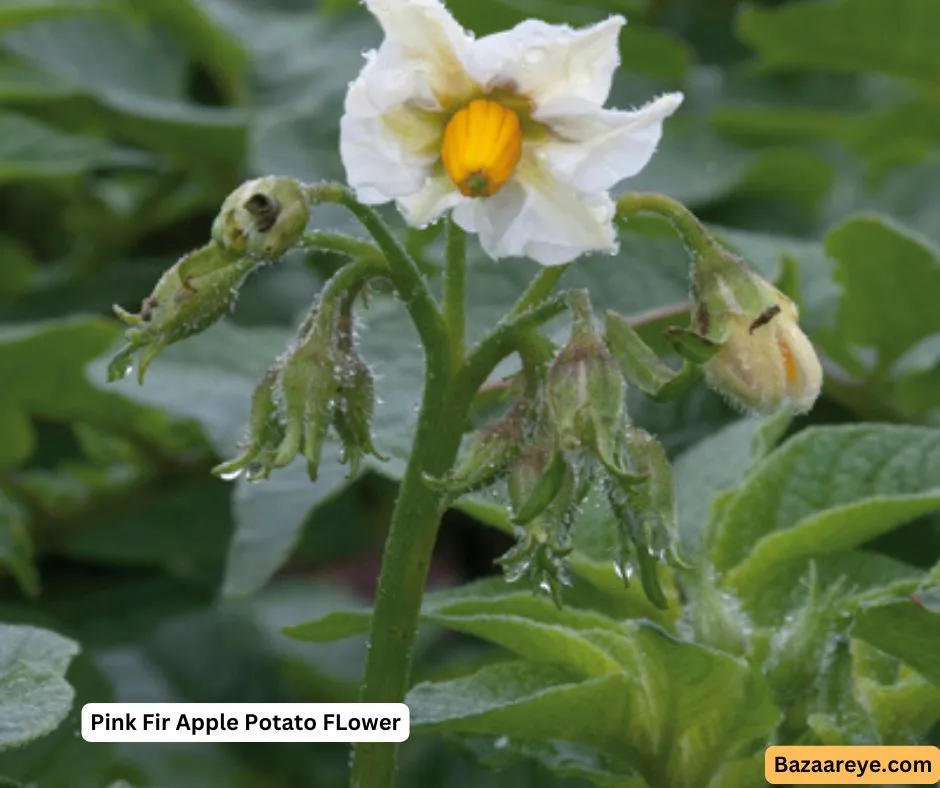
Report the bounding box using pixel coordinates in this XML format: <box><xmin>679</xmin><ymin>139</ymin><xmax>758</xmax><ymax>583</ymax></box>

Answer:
<box><xmin>464</xmin><ymin>16</ymin><xmax>626</xmax><ymax>106</ymax></box>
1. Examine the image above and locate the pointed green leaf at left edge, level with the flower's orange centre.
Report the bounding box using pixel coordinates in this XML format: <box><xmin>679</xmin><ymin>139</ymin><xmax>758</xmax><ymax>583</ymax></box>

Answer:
<box><xmin>0</xmin><ymin>112</ymin><xmax>150</xmax><ymax>182</ymax></box>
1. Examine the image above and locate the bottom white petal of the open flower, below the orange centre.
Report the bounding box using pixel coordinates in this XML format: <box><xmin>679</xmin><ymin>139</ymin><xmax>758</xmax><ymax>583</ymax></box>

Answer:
<box><xmin>453</xmin><ymin>154</ymin><xmax>617</xmax><ymax>265</ymax></box>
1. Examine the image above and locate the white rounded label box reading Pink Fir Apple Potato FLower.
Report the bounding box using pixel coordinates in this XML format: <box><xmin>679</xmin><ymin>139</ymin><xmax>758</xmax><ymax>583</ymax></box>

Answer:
<box><xmin>82</xmin><ymin>703</ymin><xmax>411</xmax><ymax>743</ymax></box>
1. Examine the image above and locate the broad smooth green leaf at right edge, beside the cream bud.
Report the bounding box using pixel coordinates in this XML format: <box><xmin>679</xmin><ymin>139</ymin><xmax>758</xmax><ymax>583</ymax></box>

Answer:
<box><xmin>826</xmin><ymin>216</ymin><xmax>940</xmax><ymax>361</ymax></box>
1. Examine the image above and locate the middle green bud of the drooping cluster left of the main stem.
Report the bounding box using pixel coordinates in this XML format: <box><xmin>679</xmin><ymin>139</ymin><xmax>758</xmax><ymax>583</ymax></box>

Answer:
<box><xmin>274</xmin><ymin>314</ymin><xmax>340</xmax><ymax>480</ymax></box>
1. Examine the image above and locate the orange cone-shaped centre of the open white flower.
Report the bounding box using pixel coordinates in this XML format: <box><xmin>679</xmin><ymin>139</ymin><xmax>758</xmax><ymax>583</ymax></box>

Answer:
<box><xmin>441</xmin><ymin>99</ymin><xmax>522</xmax><ymax>197</ymax></box>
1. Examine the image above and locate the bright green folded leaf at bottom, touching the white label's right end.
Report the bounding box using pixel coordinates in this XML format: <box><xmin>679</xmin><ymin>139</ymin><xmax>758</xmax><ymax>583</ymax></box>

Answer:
<box><xmin>408</xmin><ymin>624</ymin><xmax>778</xmax><ymax>786</ymax></box>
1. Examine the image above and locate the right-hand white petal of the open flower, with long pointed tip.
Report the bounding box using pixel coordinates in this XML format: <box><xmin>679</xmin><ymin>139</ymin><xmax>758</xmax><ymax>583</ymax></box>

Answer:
<box><xmin>533</xmin><ymin>93</ymin><xmax>682</xmax><ymax>192</ymax></box>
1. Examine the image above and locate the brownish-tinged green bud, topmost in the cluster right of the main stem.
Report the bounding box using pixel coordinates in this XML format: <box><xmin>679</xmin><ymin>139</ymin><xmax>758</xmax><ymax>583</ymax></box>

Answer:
<box><xmin>545</xmin><ymin>292</ymin><xmax>627</xmax><ymax>467</ymax></box>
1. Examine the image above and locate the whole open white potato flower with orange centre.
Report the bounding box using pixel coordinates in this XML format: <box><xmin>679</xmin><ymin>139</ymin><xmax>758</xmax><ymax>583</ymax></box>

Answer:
<box><xmin>340</xmin><ymin>0</ymin><xmax>682</xmax><ymax>265</ymax></box>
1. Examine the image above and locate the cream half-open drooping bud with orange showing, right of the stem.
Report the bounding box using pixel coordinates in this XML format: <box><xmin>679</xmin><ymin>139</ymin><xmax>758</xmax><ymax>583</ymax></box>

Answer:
<box><xmin>694</xmin><ymin>252</ymin><xmax>822</xmax><ymax>415</ymax></box>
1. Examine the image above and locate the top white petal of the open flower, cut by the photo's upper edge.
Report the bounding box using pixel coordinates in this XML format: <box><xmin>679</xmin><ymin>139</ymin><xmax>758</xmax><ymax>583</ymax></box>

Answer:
<box><xmin>366</xmin><ymin>0</ymin><xmax>473</xmax><ymax>104</ymax></box>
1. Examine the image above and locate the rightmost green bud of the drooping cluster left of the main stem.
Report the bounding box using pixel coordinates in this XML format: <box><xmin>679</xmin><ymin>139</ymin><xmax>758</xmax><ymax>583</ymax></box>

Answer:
<box><xmin>333</xmin><ymin>345</ymin><xmax>388</xmax><ymax>477</ymax></box>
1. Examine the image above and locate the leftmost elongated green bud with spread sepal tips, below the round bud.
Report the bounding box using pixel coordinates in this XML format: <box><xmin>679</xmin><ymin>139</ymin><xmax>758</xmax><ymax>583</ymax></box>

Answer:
<box><xmin>108</xmin><ymin>244</ymin><xmax>257</xmax><ymax>383</ymax></box>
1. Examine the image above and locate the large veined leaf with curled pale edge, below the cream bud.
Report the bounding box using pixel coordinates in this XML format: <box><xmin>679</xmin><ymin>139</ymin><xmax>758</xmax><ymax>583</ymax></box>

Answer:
<box><xmin>712</xmin><ymin>424</ymin><xmax>940</xmax><ymax>600</ymax></box>
